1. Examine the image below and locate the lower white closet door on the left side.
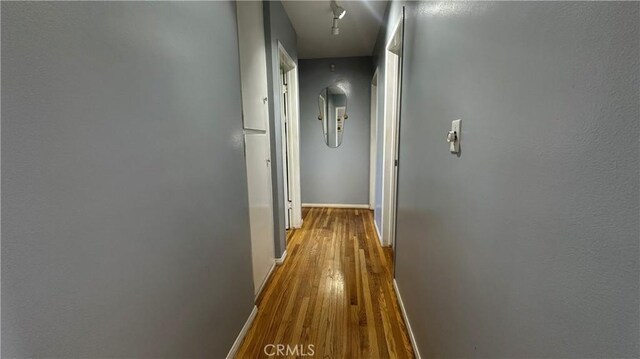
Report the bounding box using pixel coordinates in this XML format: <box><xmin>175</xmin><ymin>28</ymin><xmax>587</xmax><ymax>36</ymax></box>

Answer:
<box><xmin>244</xmin><ymin>133</ymin><xmax>275</xmax><ymax>294</ymax></box>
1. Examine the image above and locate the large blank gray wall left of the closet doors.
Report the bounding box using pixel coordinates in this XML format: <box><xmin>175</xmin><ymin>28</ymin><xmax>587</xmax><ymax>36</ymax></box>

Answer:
<box><xmin>2</xmin><ymin>2</ymin><xmax>253</xmax><ymax>358</ymax></box>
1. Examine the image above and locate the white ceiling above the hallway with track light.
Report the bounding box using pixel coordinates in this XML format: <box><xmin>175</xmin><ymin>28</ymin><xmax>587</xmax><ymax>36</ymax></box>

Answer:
<box><xmin>282</xmin><ymin>0</ymin><xmax>387</xmax><ymax>59</ymax></box>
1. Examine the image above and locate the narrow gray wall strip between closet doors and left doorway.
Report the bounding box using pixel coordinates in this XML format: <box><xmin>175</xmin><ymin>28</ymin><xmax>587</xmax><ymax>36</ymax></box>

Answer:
<box><xmin>263</xmin><ymin>0</ymin><xmax>298</xmax><ymax>257</ymax></box>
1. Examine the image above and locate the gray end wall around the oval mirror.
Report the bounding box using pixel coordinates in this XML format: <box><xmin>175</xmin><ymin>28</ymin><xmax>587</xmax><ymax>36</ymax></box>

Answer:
<box><xmin>299</xmin><ymin>57</ymin><xmax>373</xmax><ymax>204</ymax></box>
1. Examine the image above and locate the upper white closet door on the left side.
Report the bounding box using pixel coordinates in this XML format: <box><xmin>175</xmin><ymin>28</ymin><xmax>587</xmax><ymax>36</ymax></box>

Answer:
<box><xmin>236</xmin><ymin>1</ymin><xmax>269</xmax><ymax>131</ymax></box>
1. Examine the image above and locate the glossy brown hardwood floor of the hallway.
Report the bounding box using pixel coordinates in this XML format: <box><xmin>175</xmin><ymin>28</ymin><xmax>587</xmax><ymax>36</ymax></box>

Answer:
<box><xmin>236</xmin><ymin>208</ymin><xmax>414</xmax><ymax>359</ymax></box>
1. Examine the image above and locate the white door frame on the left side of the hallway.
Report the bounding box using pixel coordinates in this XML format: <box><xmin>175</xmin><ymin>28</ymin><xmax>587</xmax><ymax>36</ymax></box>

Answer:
<box><xmin>278</xmin><ymin>41</ymin><xmax>302</xmax><ymax>228</ymax></box>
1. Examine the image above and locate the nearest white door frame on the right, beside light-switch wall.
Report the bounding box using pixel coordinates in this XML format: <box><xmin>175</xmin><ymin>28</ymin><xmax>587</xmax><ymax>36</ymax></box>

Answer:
<box><xmin>381</xmin><ymin>15</ymin><xmax>403</xmax><ymax>251</ymax></box>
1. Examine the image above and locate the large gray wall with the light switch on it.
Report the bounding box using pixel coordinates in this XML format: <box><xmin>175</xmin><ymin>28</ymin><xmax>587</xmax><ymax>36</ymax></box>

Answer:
<box><xmin>376</xmin><ymin>2</ymin><xmax>640</xmax><ymax>358</ymax></box>
